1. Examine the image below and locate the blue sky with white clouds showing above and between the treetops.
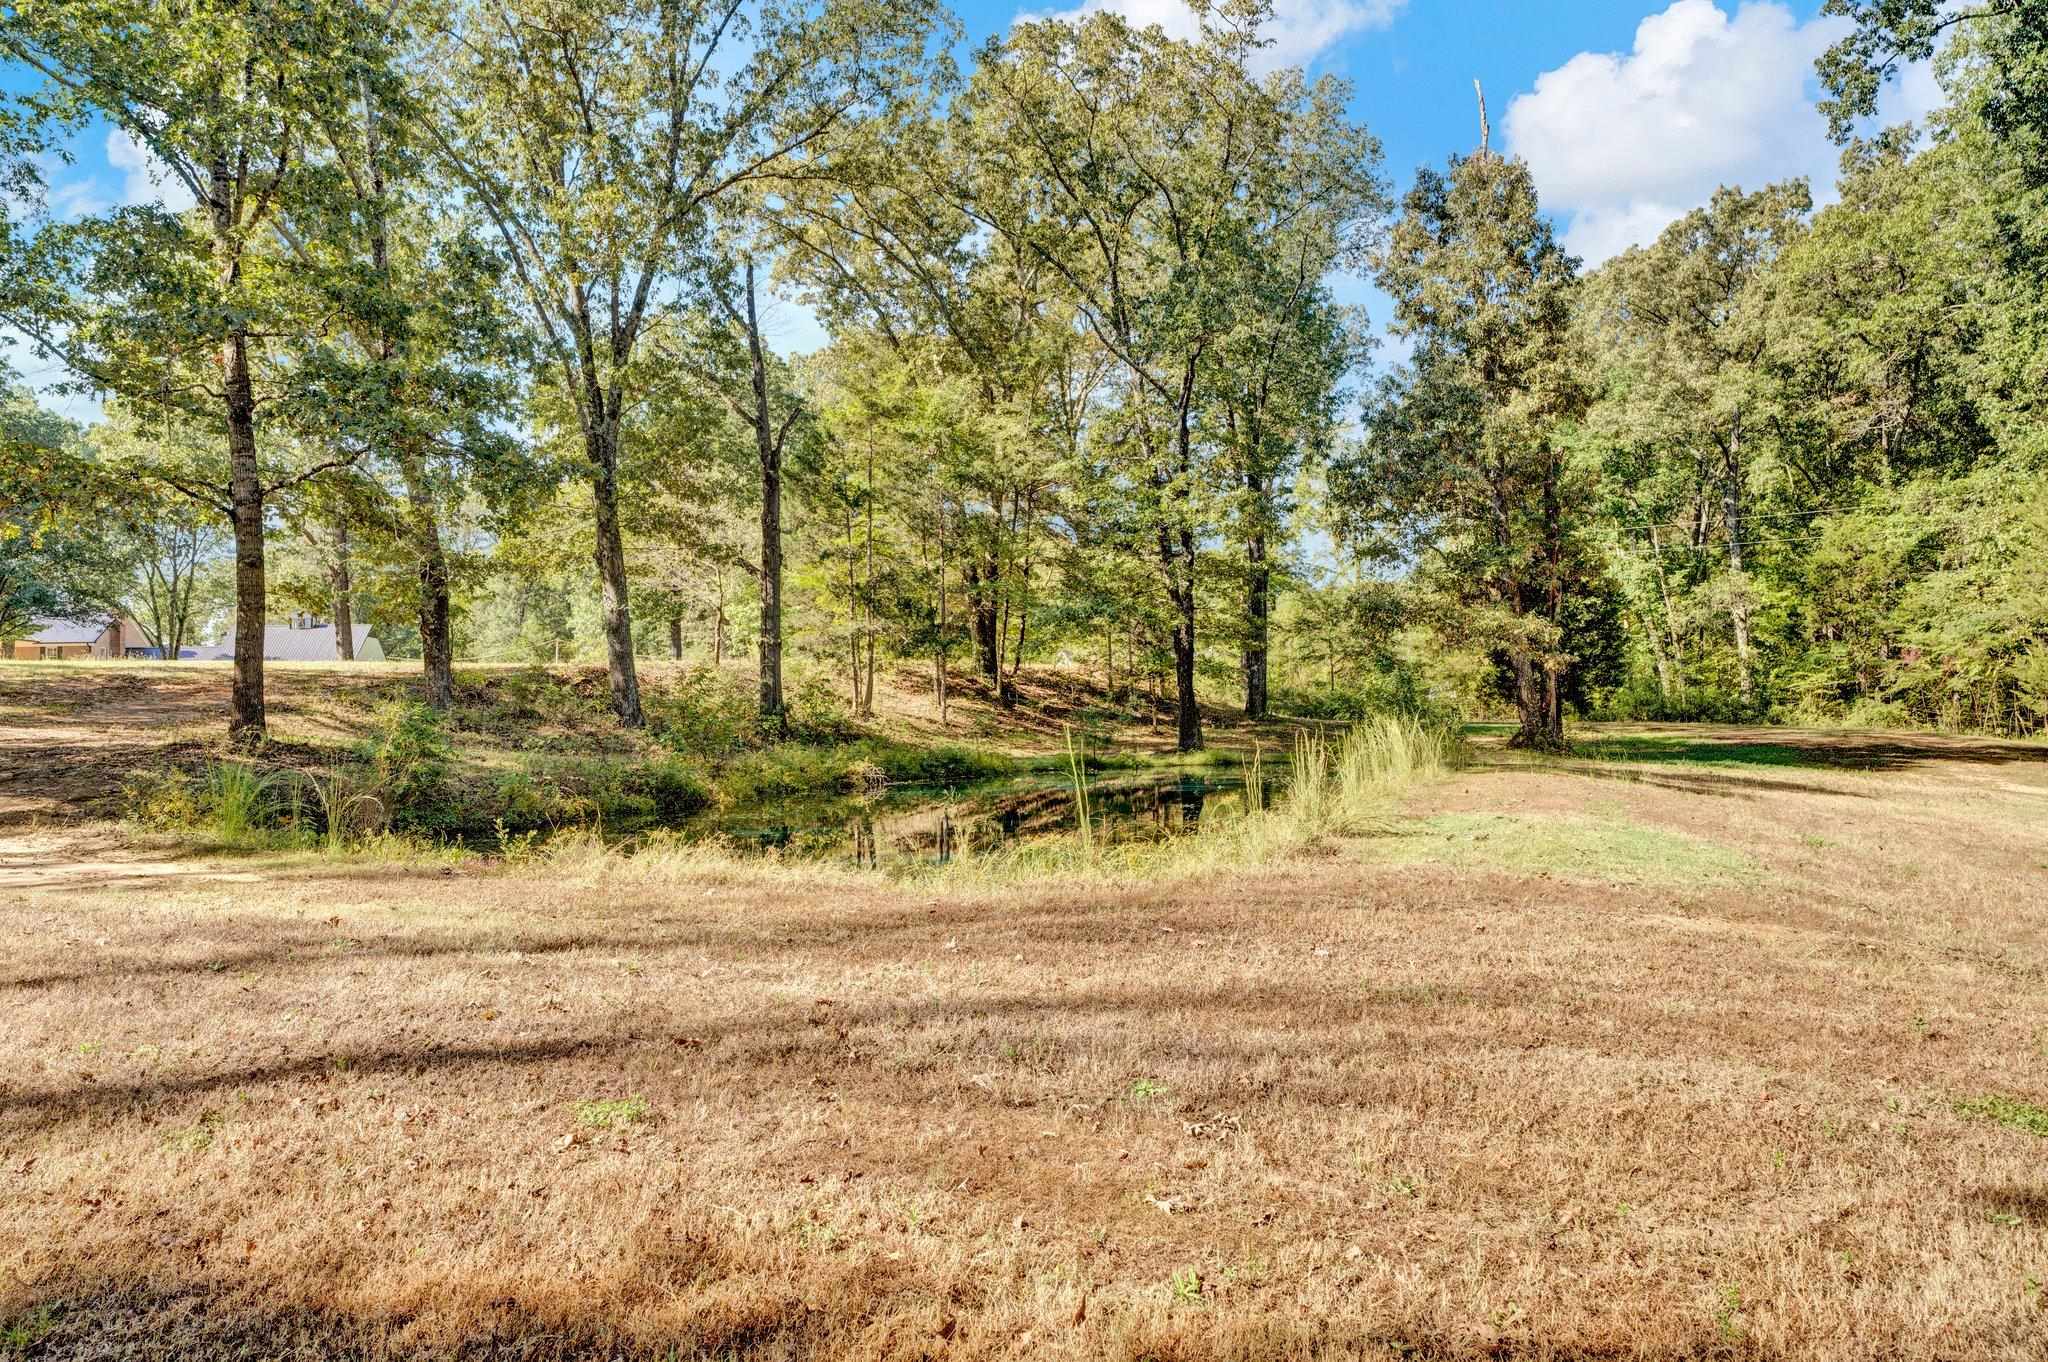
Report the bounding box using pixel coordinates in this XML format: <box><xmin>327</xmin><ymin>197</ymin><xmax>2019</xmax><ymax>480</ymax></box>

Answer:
<box><xmin>12</xmin><ymin>0</ymin><xmax>1935</xmax><ymax>401</ymax></box>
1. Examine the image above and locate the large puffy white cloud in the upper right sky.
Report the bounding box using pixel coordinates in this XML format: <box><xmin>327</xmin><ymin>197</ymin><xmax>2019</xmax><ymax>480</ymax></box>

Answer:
<box><xmin>1503</xmin><ymin>0</ymin><xmax>1845</xmax><ymax>262</ymax></box>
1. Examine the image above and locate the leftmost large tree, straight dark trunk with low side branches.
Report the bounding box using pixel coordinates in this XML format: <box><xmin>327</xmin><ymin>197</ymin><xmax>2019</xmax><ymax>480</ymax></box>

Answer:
<box><xmin>0</xmin><ymin>0</ymin><xmax>387</xmax><ymax>739</ymax></box>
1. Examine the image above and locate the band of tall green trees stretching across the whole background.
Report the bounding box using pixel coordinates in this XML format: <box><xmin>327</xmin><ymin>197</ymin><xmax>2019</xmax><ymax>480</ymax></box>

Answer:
<box><xmin>0</xmin><ymin>0</ymin><xmax>2048</xmax><ymax>750</ymax></box>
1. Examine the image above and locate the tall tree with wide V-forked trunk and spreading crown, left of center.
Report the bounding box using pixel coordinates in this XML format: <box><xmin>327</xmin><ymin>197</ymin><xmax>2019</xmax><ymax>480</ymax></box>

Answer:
<box><xmin>426</xmin><ymin>0</ymin><xmax>934</xmax><ymax>727</ymax></box>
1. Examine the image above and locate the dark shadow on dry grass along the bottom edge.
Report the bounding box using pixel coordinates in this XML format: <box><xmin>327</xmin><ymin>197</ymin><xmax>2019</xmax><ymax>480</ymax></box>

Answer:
<box><xmin>0</xmin><ymin>1278</ymin><xmax>1826</xmax><ymax>1362</ymax></box>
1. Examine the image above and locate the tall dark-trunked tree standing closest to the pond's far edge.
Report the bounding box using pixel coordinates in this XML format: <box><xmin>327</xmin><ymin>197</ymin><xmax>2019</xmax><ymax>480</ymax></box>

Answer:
<box><xmin>956</xmin><ymin>0</ymin><xmax>1378</xmax><ymax>752</ymax></box>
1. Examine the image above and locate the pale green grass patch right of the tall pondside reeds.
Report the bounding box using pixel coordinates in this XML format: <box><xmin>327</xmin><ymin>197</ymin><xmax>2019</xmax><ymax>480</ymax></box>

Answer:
<box><xmin>1368</xmin><ymin>813</ymin><xmax>1759</xmax><ymax>885</ymax></box>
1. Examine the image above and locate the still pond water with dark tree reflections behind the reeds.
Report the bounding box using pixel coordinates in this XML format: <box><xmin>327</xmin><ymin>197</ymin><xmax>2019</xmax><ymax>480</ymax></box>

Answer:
<box><xmin>692</xmin><ymin>768</ymin><xmax>1282</xmax><ymax>866</ymax></box>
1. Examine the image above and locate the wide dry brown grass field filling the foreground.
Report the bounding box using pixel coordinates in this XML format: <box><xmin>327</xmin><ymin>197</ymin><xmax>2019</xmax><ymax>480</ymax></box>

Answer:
<box><xmin>0</xmin><ymin>672</ymin><xmax>2048</xmax><ymax>1362</ymax></box>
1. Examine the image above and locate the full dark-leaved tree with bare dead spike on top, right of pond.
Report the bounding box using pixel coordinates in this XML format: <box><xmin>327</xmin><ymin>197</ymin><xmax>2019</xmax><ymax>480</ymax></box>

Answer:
<box><xmin>1331</xmin><ymin>152</ymin><xmax>1593</xmax><ymax>748</ymax></box>
